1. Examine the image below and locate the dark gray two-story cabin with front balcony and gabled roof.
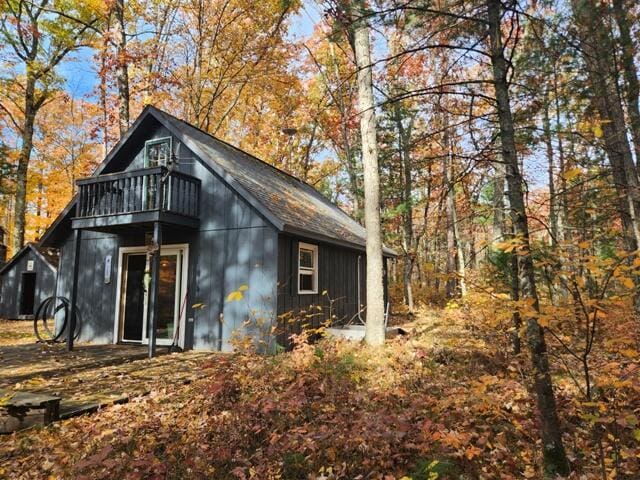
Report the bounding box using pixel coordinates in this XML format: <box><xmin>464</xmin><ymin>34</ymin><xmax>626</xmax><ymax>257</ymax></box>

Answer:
<box><xmin>42</xmin><ymin>106</ymin><xmax>393</xmax><ymax>351</ymax></box>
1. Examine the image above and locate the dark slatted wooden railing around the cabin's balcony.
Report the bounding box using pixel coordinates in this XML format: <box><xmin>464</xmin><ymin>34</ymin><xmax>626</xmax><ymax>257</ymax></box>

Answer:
<box><xmin>76</xmin><ymin>167</ymin><xmax>200</xmax><ymax>218</ymax></box>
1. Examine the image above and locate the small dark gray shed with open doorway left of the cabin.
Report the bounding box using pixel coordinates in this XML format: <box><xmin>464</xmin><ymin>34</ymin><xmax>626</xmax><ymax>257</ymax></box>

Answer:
<box><xmin>0</xmin><ymin>243</ymin><xmax>58</xmax><ymax>319</ymax></box>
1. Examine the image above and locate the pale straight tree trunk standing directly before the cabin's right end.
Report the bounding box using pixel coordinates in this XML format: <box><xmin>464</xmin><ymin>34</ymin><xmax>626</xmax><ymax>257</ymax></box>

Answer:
<box><xmin>353</xmin><ymin>8</ymin><xmax>385</xmax><ymax>345</ymax></box>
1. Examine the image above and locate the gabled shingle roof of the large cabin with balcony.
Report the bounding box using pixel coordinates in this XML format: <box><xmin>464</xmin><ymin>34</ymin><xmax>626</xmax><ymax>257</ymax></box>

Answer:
<box><xmin>43</xmin><ymin>106</ymin><xmax>394</xmax><ymax>255</ymax></box>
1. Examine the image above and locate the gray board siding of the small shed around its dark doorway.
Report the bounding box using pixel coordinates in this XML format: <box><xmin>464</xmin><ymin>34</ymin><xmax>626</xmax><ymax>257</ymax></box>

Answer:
<box><xmin>0</xmin><ymin>249</ymin><xmax>56</xmax><ymax>319</ymax></box>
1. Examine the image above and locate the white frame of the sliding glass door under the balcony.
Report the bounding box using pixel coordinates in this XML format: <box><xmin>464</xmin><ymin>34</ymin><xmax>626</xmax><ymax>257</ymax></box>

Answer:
<box><xmin>113</xmin><ymin>243</ymin><xmax>189</xmax><ymax>349</ymax></box>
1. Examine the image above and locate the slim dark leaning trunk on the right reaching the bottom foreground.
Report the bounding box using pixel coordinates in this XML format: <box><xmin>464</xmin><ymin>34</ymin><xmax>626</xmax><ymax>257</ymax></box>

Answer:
<box><xmin>487</xmin><ymin>0</ymin><xmax>571</xmax><ymax>477</ymax></box>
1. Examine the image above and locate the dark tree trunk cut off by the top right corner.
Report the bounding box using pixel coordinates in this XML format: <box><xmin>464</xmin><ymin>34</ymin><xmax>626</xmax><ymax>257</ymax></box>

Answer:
<box><xmin>613</xmin><ymin>0</ymin><xmax>640</xmax><ymax>169</ymax></box>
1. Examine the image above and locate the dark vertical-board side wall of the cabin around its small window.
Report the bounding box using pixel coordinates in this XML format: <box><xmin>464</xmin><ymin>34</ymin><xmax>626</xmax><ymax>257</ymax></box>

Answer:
<box><xmin>277</xmin><ymin>235</ymin><xmax>366</xmax><ymax>348</ymax></box>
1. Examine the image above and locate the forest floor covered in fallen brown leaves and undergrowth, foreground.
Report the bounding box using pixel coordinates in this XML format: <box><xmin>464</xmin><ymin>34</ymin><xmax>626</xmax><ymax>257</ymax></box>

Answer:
<box><xmin>0</xmin><ymin>299</ymin><xmax>640</xmax><ymax>480</ymax></box>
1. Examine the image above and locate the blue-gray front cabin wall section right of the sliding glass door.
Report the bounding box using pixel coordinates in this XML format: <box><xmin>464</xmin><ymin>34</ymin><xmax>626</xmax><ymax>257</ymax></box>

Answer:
<box><xmin>180</xmin><ymin>142</ymin><xmax>277</xmax><ymax>351</ymax></box>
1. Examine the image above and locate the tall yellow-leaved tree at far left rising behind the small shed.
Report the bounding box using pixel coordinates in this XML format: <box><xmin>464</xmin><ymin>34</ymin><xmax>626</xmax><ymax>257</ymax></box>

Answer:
<box><xmin>0</xmin><ymin>0</ymin><xmax>98</xmax><ymax>250</ymax></box>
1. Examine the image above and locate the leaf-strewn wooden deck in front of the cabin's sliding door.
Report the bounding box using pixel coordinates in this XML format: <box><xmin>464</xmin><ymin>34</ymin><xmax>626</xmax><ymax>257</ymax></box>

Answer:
<box><xmin>0</xmin><ymin>342</ymin><xmax>217</xmax><ymax>421</ymax></box>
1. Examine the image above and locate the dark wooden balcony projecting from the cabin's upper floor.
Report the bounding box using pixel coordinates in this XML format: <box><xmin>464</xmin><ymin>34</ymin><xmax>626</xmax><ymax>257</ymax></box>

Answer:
<box><xmin>72</xmin><ymin>167</ymin><xmax>200</xmax><ymax>230</ymax></box>
